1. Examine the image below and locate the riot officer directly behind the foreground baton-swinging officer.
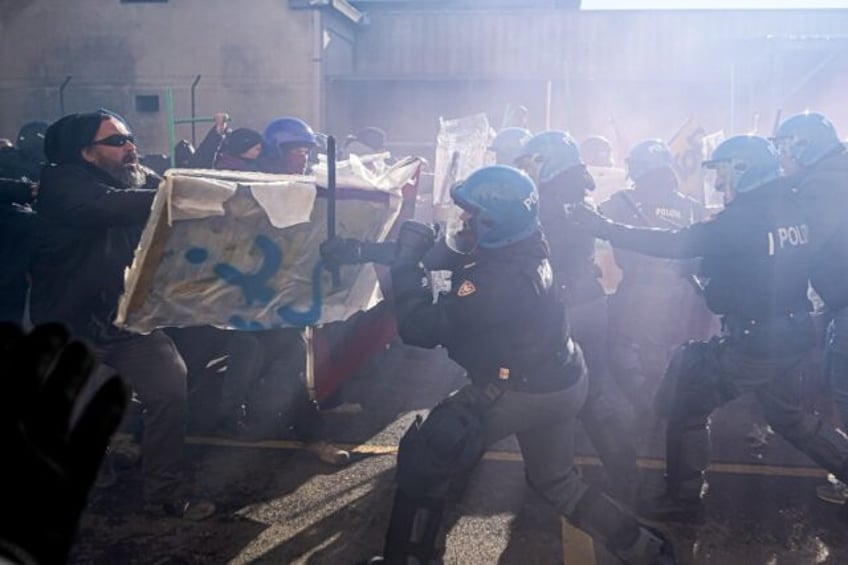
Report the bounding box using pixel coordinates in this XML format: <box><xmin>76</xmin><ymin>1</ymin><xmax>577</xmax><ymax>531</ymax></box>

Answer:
<box><xmin>523</xmin><ymin>131</ymin><xmax>638</xmax><ymax>503</ymax></box>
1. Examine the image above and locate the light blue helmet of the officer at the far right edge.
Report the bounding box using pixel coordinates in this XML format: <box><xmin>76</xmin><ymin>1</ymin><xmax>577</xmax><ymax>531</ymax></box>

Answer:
<box><xmin>774</xmin><ymin>112</ymin><xmax>842</xmax><ymax>167</ymax></box>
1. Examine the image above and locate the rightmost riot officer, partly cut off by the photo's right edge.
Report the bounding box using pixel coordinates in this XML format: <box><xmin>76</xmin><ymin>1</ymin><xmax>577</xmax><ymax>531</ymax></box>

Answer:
<box><xmin>775</xmin><ymin>112</ymin><xmax>848</xmax><ymax>503</ymax></box>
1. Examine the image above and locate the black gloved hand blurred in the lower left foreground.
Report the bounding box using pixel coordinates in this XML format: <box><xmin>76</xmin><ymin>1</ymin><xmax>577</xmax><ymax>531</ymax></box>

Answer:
<box><xmin>0</xmin><ymin>324</ymin><xmax>128</xmax><ymax>563</ymax></box>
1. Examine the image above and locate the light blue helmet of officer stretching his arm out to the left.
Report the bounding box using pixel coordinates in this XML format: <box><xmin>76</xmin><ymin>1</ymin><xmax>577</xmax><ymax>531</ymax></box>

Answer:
<box><xmin>703</xmin><ymin>135</ymin><xmax>780</xmax><ymax>194</ymax></box>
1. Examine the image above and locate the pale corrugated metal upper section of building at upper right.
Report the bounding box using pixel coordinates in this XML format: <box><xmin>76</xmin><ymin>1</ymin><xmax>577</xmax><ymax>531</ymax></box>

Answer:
<box><xmin>355</xmin><ymin>10</ymin><xmax>848</xmax><ymax>80</ymax></box>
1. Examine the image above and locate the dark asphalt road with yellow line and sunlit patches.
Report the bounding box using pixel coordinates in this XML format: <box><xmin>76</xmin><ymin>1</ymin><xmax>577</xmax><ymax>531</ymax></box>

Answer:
<box><xmin>71</xmin><ymin>343</ymin><xmax>848</xmax><ymax>565</ymax></box>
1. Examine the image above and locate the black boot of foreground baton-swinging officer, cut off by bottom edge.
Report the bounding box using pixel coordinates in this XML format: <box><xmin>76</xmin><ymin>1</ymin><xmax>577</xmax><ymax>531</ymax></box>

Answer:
<box><xmin>371</xmin><ymin>490</ymin><xmax>444</xmax><ymax>565</ymax></box>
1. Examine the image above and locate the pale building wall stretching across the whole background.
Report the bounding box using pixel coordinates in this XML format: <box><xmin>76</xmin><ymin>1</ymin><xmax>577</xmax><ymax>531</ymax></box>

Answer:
<box><xmin>0</xmin><ymin>0</ymin><xmax>848</xmax><ymax>161</ymax></box>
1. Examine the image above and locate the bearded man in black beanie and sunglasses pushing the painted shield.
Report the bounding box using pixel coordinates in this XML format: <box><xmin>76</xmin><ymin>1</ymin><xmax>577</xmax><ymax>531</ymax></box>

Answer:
<box><xmin>31</xmin><ymin>110</ymin><xmax>215</xmax><ymax>520</ymax></box>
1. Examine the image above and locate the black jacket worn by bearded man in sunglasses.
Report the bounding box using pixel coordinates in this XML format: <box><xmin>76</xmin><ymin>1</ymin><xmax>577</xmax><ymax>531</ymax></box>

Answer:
<box><xmin>31</xmin><ymin>163</ymin><xmax>159</xmax><ymax>342</ymax></box>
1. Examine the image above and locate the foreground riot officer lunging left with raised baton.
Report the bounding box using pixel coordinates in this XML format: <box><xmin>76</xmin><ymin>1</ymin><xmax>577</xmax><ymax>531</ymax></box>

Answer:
<box><xmin>322</xmin><ymin>165</ymin><xmax>674</xmax><ymax>564</ymax></box>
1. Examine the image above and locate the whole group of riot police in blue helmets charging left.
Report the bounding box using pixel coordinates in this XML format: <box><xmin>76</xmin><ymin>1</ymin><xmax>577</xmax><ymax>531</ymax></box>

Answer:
<box><xmin>1</xmin><ymin>107</ymin><xmax>848</xmax><ymax>565</ymax></box>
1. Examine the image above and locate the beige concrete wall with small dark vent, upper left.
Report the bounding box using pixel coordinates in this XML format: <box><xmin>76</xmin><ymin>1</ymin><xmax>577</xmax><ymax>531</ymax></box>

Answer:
<box><xmin>0</xmin><ymin>0</ymin><xmax>336</xmax><ymax>152</ymax></box>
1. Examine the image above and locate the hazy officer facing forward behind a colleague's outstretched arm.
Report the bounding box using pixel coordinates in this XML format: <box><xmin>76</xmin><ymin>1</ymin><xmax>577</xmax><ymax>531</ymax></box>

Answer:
<box><xmin>600</xmin><ymin>139</ymin><xmax>709</xmax><ymax>412</ymax></box>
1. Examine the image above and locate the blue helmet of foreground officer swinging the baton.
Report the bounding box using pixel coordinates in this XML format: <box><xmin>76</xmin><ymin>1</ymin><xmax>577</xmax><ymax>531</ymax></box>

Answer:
<box><xmin>451</xmin><ymin>165</ymin><xmax>539</xmax><ymax>252</ymax></box>
